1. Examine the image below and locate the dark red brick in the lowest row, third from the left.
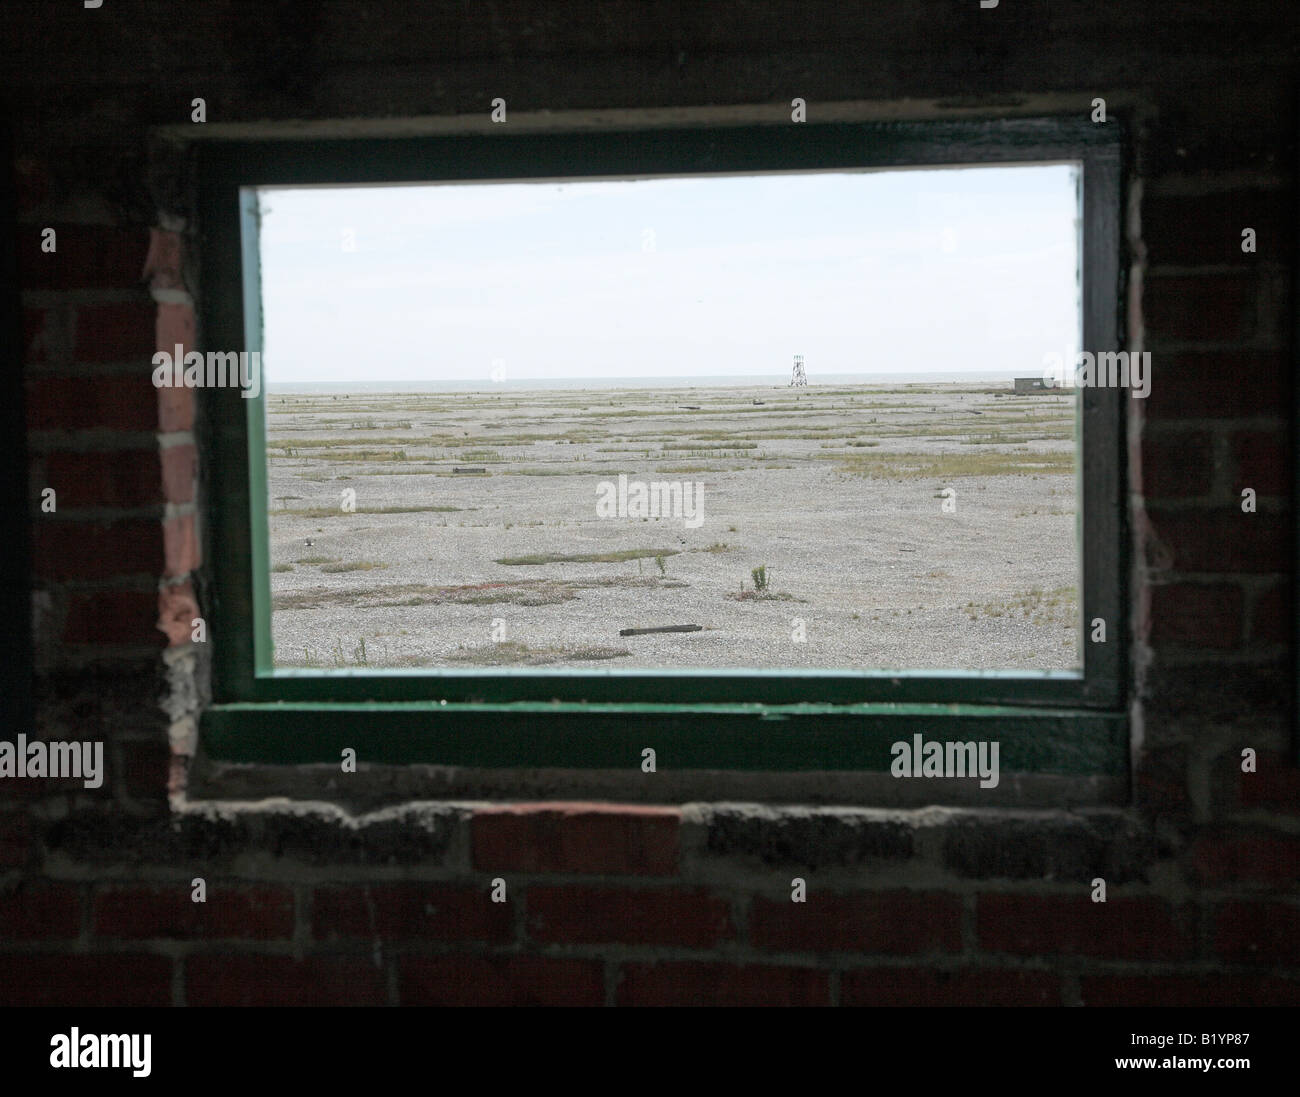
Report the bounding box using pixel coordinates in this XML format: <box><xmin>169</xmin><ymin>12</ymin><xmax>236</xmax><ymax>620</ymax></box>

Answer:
<box><xmin>400</xmin><ymin>954</ymin><xmax>605</xmax><ymax>1006</ymax></box>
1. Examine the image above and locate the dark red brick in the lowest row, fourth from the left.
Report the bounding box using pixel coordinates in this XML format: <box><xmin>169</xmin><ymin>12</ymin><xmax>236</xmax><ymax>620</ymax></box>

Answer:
<box><xmin>618</xmin><ymin>962</ymin><xmax>831</xmax><ymax>1006</ymax></box>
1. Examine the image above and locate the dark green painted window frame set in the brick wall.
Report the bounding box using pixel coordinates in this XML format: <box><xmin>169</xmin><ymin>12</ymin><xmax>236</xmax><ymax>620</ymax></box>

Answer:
<box><xmin>198</xmin><ymin>117</ymin><xmax>1128</xmax><ymax>776</ymax></box>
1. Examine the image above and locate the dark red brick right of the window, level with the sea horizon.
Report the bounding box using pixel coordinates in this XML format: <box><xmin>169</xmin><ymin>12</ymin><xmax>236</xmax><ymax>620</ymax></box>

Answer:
<box><xmin>1143</xmin><ymin>351</ymin><xmax>1291</xmax><ymax>420</ymax></box>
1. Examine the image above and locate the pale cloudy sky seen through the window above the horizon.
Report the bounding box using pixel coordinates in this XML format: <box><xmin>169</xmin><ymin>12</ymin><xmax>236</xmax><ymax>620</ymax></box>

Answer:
<box><xmin>250</xmin><ymin>165</ymin><xmax>1079</xmax><ymax>387</ymax></box>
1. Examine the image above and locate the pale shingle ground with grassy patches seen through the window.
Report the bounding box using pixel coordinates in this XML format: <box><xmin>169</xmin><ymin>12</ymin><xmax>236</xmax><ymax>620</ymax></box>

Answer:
<box><xmin>268</xmin><ymin>383</ymin><xmax>1080</xmax><ymax>671</ymax></box>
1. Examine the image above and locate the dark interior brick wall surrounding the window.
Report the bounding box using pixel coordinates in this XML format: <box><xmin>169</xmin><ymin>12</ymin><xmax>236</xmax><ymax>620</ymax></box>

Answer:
<box><xmin>0</xmin><ymin>0</ymin><xmax>1300</xmax><ymax>1005</ymax></box>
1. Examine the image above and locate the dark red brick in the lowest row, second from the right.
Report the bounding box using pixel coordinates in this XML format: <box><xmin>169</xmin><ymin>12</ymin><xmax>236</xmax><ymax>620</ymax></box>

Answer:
<box><xmin>840</xmin><ymin>967</ymin><xmax>1061</xmax><ymax>1006</ymax></box>
